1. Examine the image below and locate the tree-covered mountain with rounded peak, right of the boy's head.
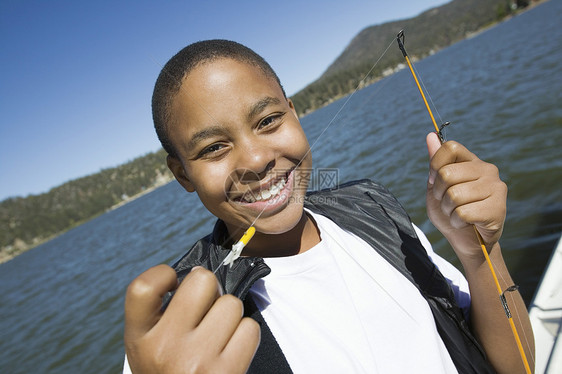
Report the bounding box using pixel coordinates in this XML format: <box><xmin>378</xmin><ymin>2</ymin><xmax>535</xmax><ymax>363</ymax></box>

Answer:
<box><xmin>291</xmin><ymin>0</ymin><xmax>512</xmax><ymax>115</ymax></box>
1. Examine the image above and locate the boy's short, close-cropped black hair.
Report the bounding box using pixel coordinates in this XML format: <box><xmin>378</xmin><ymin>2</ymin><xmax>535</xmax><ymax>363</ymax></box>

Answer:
<box><xmin>152</xmin><ymin>39</ymin><xmax>287</xmax><ymax>157</ymax></box>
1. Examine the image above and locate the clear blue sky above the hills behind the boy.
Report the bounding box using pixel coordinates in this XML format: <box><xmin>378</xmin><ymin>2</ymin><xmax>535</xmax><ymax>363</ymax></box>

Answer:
<box><xmin>0</xmin><ymin>0</ymin><xmax>447</xmax><ymax>200</ymax></box>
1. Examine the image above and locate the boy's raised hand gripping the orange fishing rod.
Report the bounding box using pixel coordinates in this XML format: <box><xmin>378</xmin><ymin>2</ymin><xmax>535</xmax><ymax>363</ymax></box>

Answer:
<box><xmin>426</xmin><ymin>133</ymin><xmax>507</xmax><ymax>260</ymax></box>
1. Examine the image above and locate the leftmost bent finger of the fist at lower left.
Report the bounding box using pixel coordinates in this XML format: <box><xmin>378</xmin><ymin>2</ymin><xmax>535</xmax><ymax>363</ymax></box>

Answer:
<box><xmin>125</xmin><ymin>265</ymin><xmax>178</xmax><ymax>339</ymax></box>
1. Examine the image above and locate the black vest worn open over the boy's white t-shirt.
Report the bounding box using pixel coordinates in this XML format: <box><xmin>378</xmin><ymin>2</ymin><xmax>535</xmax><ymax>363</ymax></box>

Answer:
<box><xmin>165</xmin><ymin>180</ymin><xmax>495</xmax><ymax>374</ymax></box>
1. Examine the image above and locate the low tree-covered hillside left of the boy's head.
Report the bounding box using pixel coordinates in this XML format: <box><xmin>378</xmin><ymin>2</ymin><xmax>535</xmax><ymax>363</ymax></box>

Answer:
<box><xmin>0</xmin><ymin>150</ymin><xmax>172</xmax><ymax>263</ymax></box>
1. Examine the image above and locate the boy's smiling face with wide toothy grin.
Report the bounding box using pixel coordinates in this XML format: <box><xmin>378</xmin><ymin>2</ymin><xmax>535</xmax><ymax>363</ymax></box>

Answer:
<box><xmin>168</xmin><ymin>58</ymin><xmax>312</xmax><ymax>234</ymax></box>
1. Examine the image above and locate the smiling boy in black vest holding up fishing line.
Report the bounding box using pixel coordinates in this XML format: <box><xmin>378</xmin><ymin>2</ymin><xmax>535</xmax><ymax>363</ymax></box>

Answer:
<box><xmin>125</xmin><ymin>40</ymin><xmax>534</xmax><ymax>373</ymax></box>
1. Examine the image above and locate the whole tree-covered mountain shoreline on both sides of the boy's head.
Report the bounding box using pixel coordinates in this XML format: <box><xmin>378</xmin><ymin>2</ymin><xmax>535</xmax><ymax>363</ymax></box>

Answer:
<box><xmin>0</xmin><ymin>0</ymin><xmax>526</xmax><ymax>263</ymax></box>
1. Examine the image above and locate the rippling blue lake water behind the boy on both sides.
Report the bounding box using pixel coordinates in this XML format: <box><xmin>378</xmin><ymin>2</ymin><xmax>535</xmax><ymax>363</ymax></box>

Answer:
<box><xmin>0</xmin><ymin>0</ymin><xmax>562</xmax><ymax>373</ymax></box>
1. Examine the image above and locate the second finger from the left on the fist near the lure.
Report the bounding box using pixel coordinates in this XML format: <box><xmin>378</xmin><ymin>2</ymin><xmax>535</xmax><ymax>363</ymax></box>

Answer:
<box><xmin>159</xmin><ymin>267</ymin><xmax>222</xmax><ymax>331</ymax></box>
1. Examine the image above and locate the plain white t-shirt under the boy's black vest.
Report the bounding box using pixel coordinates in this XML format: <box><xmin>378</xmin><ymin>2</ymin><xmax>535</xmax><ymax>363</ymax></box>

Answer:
<box><xmin>250</xmin><ymin>211</ymin><xmax>470</xmax><ymax>374</ymax></box>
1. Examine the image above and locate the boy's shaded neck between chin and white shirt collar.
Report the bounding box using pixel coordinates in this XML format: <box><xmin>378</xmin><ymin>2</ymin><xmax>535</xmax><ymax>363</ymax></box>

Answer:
<box><xmin>237</xmin><ymin>210</ymin><xmax>320</xmax><ymax>257</ymax></box>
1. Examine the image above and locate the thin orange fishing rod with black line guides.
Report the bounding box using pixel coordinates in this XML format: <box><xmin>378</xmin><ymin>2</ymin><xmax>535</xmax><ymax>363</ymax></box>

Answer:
<box><xmin>396</xmin><ymin>30</ymin><xmax>531</xmax><ymax>374</ymax></box>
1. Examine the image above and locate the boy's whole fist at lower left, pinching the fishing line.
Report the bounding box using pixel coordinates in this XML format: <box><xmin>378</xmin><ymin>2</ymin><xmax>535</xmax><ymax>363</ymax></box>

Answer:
<box><xmin>125</xmin><ymin>265</ymin><xmax>260</xmax><ymax>373</ymax></box>
